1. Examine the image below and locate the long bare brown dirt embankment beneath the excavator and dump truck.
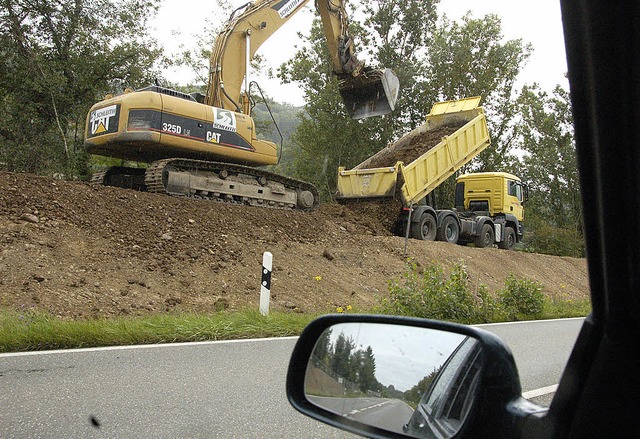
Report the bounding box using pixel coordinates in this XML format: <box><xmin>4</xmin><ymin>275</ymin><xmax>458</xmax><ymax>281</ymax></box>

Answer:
<box><xmin>0</xmin><ymin>172</ymin><xmax>588</xmax><ymax>318</ymax></box>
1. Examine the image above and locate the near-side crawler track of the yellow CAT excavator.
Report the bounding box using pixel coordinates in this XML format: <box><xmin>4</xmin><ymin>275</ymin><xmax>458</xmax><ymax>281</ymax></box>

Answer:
<box><xmin>145</xmin><ymin>159</ymin><xmax>320</xmax><ymax>210</ymax></box>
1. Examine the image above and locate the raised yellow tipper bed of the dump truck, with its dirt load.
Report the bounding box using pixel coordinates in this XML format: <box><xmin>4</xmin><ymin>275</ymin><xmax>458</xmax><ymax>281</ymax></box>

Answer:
<box><xmin>337</xmin><ymin>97</ymin><xmax>491</xmax><ymax>206</ymax></box>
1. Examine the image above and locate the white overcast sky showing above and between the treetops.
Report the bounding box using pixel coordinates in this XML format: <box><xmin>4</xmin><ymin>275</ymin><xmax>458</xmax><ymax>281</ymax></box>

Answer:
<box><xmin>152</xmin><ymin>0</ymin><xmax>568</xmax><ymax>105</ymax></box>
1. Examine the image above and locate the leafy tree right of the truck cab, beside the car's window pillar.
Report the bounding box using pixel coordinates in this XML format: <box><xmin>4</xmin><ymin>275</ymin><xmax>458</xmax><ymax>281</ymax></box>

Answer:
<box><xmin>517</xmin><ymin>85</ymin><xmax>584</xmax><ymax>257</ymax></box>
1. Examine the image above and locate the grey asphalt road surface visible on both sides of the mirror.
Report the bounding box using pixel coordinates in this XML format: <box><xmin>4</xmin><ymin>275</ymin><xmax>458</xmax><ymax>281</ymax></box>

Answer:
<box><xmin>0</xmin><ymin>320</ymin><xmax>581</xmax><ymax>438</ymax></box>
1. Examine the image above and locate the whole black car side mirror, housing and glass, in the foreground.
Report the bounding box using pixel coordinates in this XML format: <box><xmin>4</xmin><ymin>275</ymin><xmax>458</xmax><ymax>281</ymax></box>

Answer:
<box><xmin>287</xmin><ymin>315</ymin><xmax>539</xmax><ymax>438</ymax></box>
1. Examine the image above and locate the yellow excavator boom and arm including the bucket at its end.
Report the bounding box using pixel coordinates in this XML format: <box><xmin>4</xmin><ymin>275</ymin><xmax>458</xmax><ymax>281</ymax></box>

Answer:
<box><xmin>205</xmin><ymin>0</ymin><xmax>399</xmax><ymax>119</ymax></box>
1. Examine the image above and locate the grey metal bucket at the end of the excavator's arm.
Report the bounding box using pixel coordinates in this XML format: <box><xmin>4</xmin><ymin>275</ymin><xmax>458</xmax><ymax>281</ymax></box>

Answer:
<box><xmin>338</xmin><ymin>69</ymin><xmax>400</xmax><ymax>119</ymax></box>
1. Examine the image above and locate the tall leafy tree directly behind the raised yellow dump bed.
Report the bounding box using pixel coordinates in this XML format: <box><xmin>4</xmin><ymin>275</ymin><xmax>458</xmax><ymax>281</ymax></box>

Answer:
<box><xmin>423</xmin><ymin>13</ymin><xmax>532</xmax><ymax>207</ymax></box>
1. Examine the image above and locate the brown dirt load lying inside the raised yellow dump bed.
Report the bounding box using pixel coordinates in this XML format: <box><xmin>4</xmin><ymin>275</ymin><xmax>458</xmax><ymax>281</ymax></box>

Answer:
<box><xmin>355</xmin><ymin>123</ymin><xmax>464</xmax><ymax>169</ymax></box>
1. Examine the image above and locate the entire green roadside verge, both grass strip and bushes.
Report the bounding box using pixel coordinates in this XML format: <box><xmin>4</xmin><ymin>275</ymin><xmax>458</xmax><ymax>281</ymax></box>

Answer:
<box><xmin>0</xmin><ymin>274</ymin><xmax>591</xmax><ymax>352</ymax></box>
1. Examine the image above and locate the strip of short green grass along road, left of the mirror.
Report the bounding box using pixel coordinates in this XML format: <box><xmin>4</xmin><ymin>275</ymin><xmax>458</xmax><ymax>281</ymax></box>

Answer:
<box><xmin>0</xmin><ymin>309</ymin><xmax>316</xmax><ymax>352</ymax></box>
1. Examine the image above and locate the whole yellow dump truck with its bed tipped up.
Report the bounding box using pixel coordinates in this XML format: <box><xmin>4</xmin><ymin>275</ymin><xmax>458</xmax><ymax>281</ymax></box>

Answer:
<box><xmin>337</xmin><ymin>97</ymin><xmax>527</xmax><ymax>249</ymax></box>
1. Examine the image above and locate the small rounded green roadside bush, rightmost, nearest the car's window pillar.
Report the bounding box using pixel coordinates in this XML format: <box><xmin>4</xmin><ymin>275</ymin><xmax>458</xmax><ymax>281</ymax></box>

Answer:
<box><xmin>498</xmin><ymin>274</ymin><xmax>545</xmax><ymax>320</ymax></box>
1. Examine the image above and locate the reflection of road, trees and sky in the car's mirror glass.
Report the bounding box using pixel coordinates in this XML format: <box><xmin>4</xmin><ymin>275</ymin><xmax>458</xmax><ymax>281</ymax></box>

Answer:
<box><xmin>304</xmin><ymin>322</ymin><xmax>483</xmax><ymax>438</ymax></box>
